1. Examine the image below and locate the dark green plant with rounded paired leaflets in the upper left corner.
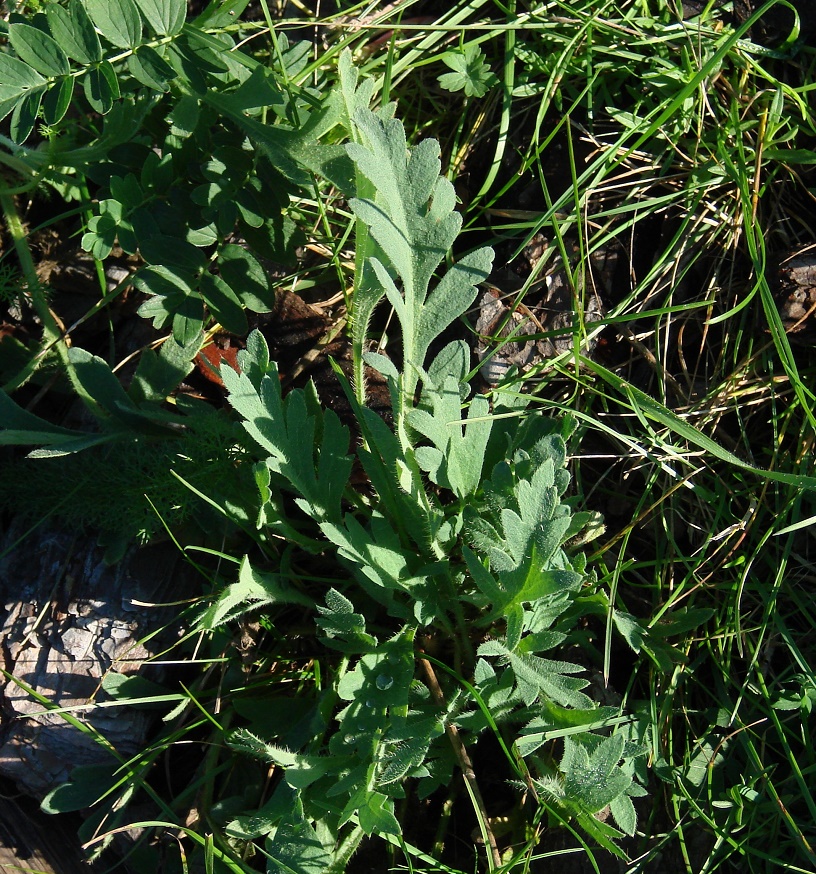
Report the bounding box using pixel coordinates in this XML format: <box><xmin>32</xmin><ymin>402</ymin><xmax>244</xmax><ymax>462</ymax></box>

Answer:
<box><xmin>0</xmin><ymin>0</ymin><xmax>321</xmax><ymax>400</ymax></box>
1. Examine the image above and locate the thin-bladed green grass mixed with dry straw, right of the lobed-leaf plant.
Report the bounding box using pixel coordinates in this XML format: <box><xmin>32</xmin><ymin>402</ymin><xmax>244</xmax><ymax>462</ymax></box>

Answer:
<box><xmin>4</xmin><ymin>0</ymin><xmax>816</xmax><ymax>874</ymax></box>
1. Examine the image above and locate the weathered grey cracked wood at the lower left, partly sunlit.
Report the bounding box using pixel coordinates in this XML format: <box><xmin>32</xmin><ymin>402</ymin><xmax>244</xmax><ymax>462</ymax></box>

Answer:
<box><xmin>0</xmin><ymin>525</ymin><xmax>199</xmax><ymax>874</ymax></box>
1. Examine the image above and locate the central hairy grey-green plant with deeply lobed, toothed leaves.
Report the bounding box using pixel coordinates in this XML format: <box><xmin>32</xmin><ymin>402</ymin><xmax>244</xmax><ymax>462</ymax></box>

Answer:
<box><xmin>210</xmin><ymin>100</ymin><xmax>648</xmax><ymax>871</ymax></box>
